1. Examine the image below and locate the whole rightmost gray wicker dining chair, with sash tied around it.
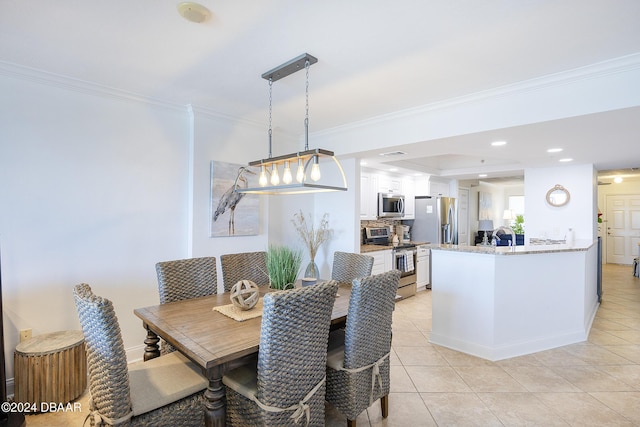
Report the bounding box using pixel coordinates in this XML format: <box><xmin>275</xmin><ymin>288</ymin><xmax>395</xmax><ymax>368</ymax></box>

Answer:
<box><xmin>326</xmin><ymin>270</ymin><xmax>400</xmax><ymax>427</ymax></box>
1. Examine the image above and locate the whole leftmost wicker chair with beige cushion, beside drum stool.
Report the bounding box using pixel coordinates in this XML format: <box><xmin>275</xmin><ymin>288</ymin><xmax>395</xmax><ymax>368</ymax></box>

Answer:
<box><xmin>73</xmin><ymin>283</ymin><xmax>208</xmax><ymax>426</ymax></box>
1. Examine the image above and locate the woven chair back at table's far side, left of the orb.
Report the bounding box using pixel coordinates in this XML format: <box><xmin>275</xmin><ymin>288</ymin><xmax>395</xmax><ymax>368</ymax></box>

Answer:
<box><xmin>156</xmin><ymin>257</ymin><xmax>218</xmax><ymax>304</ymax></box>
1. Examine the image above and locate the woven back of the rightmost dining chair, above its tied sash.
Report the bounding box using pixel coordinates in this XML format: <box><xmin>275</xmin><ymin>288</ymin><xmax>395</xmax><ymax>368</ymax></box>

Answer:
<box><xmin>344</xmin><ymin>270</ymin><xmax>400</xmax><ymax>369</ymax></box>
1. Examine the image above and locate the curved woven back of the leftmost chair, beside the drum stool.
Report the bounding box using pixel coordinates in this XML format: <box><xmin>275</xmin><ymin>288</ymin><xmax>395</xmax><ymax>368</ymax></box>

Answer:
<box><xmin>73</xmin><ymin>283</ymin><xmax>131</xmax><ymax>420</ymax></box>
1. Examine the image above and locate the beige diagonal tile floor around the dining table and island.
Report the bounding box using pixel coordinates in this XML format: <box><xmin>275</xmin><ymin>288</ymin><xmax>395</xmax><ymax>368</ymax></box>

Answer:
<box><xmin>27</xmin><ymin>264</ymin><xmax>640</xmax><ymax>427</ymax></box>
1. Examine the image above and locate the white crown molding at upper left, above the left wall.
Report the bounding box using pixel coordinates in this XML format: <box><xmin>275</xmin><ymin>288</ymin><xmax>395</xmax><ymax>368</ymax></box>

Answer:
<box><xmin>0</xmin><ymin>61</ymin><xmax>186</xmax><ymax>112</ymax></box>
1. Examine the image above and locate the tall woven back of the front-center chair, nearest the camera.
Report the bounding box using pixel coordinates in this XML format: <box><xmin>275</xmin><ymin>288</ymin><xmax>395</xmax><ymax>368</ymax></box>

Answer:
<box><xmin>257</xmin><ymin>281</ymin><xmax>338</xmax><ymax>425</ymax></box>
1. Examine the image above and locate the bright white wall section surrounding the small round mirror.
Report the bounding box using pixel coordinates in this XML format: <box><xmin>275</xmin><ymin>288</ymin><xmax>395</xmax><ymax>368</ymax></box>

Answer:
<box><xmin>524</xmin><ymin>165</ymin><xmax>597</xmax><ymax>241</ymax></box>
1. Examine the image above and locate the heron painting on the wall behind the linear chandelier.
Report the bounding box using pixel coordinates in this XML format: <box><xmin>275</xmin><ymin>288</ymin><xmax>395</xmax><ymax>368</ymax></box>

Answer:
<box><xmin>209</xmin><ymin>160</ymin><xmax>260</xmax><ymax>237</ymax></box>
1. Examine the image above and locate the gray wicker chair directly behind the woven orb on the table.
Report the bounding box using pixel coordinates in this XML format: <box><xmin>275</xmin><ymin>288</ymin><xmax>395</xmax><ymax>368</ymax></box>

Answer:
<box><xmin>220</xmin><ymin>251</ymin><xmax>269</xmax><ymax>292</ymax></box>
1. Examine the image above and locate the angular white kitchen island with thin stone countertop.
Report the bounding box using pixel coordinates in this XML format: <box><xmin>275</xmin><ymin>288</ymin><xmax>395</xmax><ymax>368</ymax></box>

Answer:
<box><xmin>430</xmin><ymin>241</ymin><xmax>599</xmax><ymax>361</ymax></box>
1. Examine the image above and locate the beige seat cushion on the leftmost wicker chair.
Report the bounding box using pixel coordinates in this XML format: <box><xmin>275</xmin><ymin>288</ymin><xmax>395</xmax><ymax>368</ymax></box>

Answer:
<box><xmin>129</xmin><ymin>351</ymin><xmax>209</xmax><ymax>416</ymax></box>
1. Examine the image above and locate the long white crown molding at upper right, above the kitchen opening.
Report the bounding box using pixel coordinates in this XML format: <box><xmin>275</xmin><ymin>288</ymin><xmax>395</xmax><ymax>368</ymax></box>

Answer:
<box><xmin>312</xmin><ymin>53</ymin><xmax>640</xmax><ymax>137</ymax></box>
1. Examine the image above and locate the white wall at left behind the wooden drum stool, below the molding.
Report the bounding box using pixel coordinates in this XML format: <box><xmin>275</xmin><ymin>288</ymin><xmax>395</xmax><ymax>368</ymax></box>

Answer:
<box><xmin>0</xmin><ymin>76</ymin><xmax>189</xmax><ymax>378</ymax></box>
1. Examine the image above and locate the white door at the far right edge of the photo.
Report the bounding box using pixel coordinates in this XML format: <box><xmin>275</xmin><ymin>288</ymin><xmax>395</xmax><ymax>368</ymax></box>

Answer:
<box><xmin>605</xmin><ymin>195</ymin><xmax>640</xmax><ymax>264</ymax></box>
